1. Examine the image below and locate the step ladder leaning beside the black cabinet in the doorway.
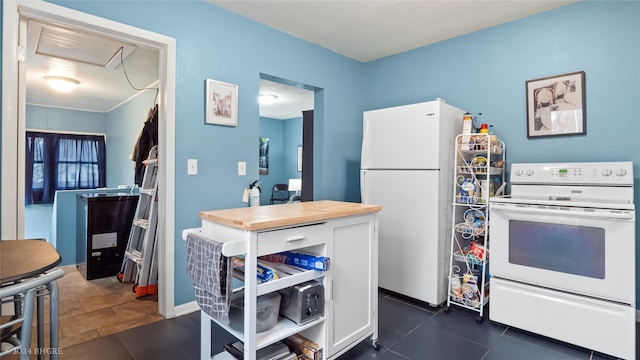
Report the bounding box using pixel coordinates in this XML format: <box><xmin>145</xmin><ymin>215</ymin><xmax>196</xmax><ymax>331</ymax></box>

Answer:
<box><xmin>118</xmin><ymin>146</ymin><xmax>158</xmax><ymax>298</ymax></box>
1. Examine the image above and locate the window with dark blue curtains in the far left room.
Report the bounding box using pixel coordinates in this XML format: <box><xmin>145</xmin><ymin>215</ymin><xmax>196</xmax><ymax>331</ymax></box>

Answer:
<box><xmin>25</xmin><ymin>131</ymin><xmax>106</xmax><ymax>205</ymax></box>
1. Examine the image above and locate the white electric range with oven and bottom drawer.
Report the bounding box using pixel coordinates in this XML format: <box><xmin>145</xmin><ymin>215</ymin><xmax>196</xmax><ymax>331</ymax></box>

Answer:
<box><xmin>489</xmin><ymin>162</ymin><xmax>636</xmax><ymax>359</ymax></box>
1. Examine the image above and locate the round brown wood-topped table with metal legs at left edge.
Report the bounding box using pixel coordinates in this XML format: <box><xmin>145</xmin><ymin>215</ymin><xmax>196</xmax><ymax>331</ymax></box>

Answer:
<box><xmin>0</xmin><ymin>240</ymin><xmax>62</xmax><ymax>359</ymax></box>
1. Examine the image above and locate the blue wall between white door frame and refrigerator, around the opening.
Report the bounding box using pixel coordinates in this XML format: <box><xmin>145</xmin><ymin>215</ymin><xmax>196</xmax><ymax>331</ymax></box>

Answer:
<box><xmin>40</xmin><ymin>1</ymin><xmax>365</xmax><ymax>305</ymax></box>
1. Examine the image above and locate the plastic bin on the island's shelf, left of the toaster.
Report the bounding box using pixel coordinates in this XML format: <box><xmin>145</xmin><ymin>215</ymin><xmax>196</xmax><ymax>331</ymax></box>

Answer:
<box><xmin>229</xmin><ymin>290</ymin><xmax>280</xmax><ymax>332</ymax></box>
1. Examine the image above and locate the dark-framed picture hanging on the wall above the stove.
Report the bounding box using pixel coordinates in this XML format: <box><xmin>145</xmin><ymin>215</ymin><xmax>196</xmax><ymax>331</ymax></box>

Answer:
<box><xmin>526</xmin><ymin>71</ymin><xmax>586</xmax><ymax>138</ymax></box>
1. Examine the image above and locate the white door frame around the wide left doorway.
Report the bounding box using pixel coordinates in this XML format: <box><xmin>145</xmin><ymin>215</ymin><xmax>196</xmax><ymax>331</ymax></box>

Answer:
<box><xmin>0</xmin><ymin>0</ymin><xmax>176</xmax><ymax>318</ymax></box>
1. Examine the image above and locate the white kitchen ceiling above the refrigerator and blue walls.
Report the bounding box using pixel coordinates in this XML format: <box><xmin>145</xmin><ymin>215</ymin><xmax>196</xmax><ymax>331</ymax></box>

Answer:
<box><xmin>208</xmin><ymin>0</ymin><xmax>577</xmax><ymax>62</ymax></box>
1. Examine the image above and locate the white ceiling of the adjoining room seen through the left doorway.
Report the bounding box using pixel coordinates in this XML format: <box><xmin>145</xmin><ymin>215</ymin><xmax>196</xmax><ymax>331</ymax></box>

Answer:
<box><xmin>25</xmin><ymin>19</ymin><xmax>158</xmax><ymax>112</ymax></box>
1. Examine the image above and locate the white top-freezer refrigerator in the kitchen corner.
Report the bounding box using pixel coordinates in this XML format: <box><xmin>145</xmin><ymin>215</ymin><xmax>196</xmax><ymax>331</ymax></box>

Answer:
<box><xmin>360</xmin><ymin>100</ymin><xmax>465</xmax><ymax>306</ymax></box>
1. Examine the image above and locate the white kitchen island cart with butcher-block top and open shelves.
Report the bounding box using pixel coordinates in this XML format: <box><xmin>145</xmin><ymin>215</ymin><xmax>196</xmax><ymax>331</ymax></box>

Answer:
<box><xmin>188</xmin><ymin>201</ymin><xmax>381</xmax><ymax>360</ymax></box>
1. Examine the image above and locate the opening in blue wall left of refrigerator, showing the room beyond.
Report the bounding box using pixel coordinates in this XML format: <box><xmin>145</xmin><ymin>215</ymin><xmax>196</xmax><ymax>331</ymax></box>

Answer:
<box><xmin>258</xmin><ymin>75</ymin><xmax>314</xmax><ymax>205</ymax></box>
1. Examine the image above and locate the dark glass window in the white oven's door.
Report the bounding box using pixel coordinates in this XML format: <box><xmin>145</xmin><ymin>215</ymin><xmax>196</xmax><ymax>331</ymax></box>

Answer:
<box><xmin>509</xmin><ymin>220</ymin><xmax>605</xmax><ymax>279</ymax></box>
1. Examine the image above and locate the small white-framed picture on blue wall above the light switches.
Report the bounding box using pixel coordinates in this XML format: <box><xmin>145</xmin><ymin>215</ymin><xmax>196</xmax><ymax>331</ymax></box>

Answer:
<box><xmin>205</xmin><ymin>79</ymin><xmax>238</xmax><ymax>126</ymax></box>
